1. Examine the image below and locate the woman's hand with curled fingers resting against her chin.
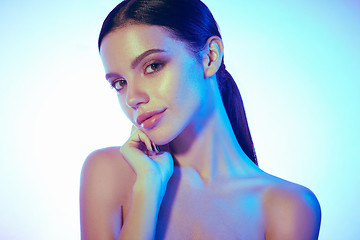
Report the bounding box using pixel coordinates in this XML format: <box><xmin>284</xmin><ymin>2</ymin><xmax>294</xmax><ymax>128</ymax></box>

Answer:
<box><xmin>120</xmin><ymin>126</ymin><xmax>174</xmax><ymax>195</ymax></box>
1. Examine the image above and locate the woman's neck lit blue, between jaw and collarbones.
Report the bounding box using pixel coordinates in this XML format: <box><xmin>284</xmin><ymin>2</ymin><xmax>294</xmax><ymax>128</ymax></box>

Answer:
<box><xmin>169</xmin><ymin>79</ymin><xmax>259</xmax><ymax>183</ymax></box>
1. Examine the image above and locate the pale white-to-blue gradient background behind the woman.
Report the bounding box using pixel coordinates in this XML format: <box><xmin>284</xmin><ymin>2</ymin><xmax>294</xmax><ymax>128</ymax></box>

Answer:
<box><xmin>0</xmin><ymin>0</ymin><xmax>360</xmax><ymax>240</ymax></box>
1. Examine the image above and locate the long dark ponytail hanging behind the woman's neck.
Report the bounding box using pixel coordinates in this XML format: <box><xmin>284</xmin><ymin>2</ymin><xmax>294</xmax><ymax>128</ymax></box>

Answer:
<box><xmin>216</xmin><ymin>62</ymin><xmax>258</xmax><ymax>165</ymax></box>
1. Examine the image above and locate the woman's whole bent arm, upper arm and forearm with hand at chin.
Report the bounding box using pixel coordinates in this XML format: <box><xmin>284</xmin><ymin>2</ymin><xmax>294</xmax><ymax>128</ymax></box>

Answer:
<box><xmin>80</xmin><ymin>130</ymin><xmax>173</xmax><ymax>240</ymax></box>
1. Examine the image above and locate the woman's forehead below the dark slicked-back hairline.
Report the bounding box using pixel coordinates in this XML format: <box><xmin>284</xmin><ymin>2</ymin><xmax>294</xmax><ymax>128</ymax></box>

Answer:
<box><xmin>100</xmin><ymin>25</ymin><xmax>193</xmax><ymax>73</ymax></box>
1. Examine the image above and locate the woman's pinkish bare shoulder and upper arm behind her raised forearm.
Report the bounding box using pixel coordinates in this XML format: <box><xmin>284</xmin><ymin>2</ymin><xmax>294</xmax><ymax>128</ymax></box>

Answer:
<box><xmin>80</xmin><ymin>147</ymin><xmax>135</xmax><ymax>239</ymax></box>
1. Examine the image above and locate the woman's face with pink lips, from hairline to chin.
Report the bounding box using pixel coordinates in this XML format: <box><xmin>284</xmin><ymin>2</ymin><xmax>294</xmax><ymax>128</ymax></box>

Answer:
<box><xmin>100</xmin><ymin>24</ymin><xmax>207</xmax><ymax>145</ymax></box>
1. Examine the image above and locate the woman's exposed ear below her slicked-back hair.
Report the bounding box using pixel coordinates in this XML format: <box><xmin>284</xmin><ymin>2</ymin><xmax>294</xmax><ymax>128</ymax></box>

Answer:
<box><xmin>203</xmin><ymin>36</ymin><xmax>224</xmax><ymax>78</ymax></box>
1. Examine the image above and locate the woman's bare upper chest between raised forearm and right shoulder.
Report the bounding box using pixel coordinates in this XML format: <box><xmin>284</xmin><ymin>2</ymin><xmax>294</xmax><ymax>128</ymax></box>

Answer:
<box><xmin>156</xmin><ymin>171</ymin><xmax>265</xmax><ymax>240</ymax></box>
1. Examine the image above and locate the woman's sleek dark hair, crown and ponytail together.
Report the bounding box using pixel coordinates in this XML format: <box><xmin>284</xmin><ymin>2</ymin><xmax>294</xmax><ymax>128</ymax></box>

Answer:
<box><xmin>98</xmin><ymin>0</ymin><xmax>257</xmax><ymax>164</ymax></box>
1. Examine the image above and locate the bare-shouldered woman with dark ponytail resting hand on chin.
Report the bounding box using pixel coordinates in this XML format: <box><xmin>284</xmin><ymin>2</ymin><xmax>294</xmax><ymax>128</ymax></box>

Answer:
<box><xmin>80</xmin><ymin>0</ymin><xmax>320</xmax><ymax>240</ymax></box>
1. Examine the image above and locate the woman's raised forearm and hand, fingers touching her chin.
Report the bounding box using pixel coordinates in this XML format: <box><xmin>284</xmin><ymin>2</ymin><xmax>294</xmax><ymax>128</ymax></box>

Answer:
<box><xmin>119</xmin><ymin>129</ymin><xmax>174</xmax><ymax>240</ymax></box>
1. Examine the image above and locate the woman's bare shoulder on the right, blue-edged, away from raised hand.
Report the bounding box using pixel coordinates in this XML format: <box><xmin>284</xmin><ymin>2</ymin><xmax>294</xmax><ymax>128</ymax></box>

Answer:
<box><xmin>262</xmin><ymin>175</ymin><xmax>321</xmax><ymax>240</ymax></box>
